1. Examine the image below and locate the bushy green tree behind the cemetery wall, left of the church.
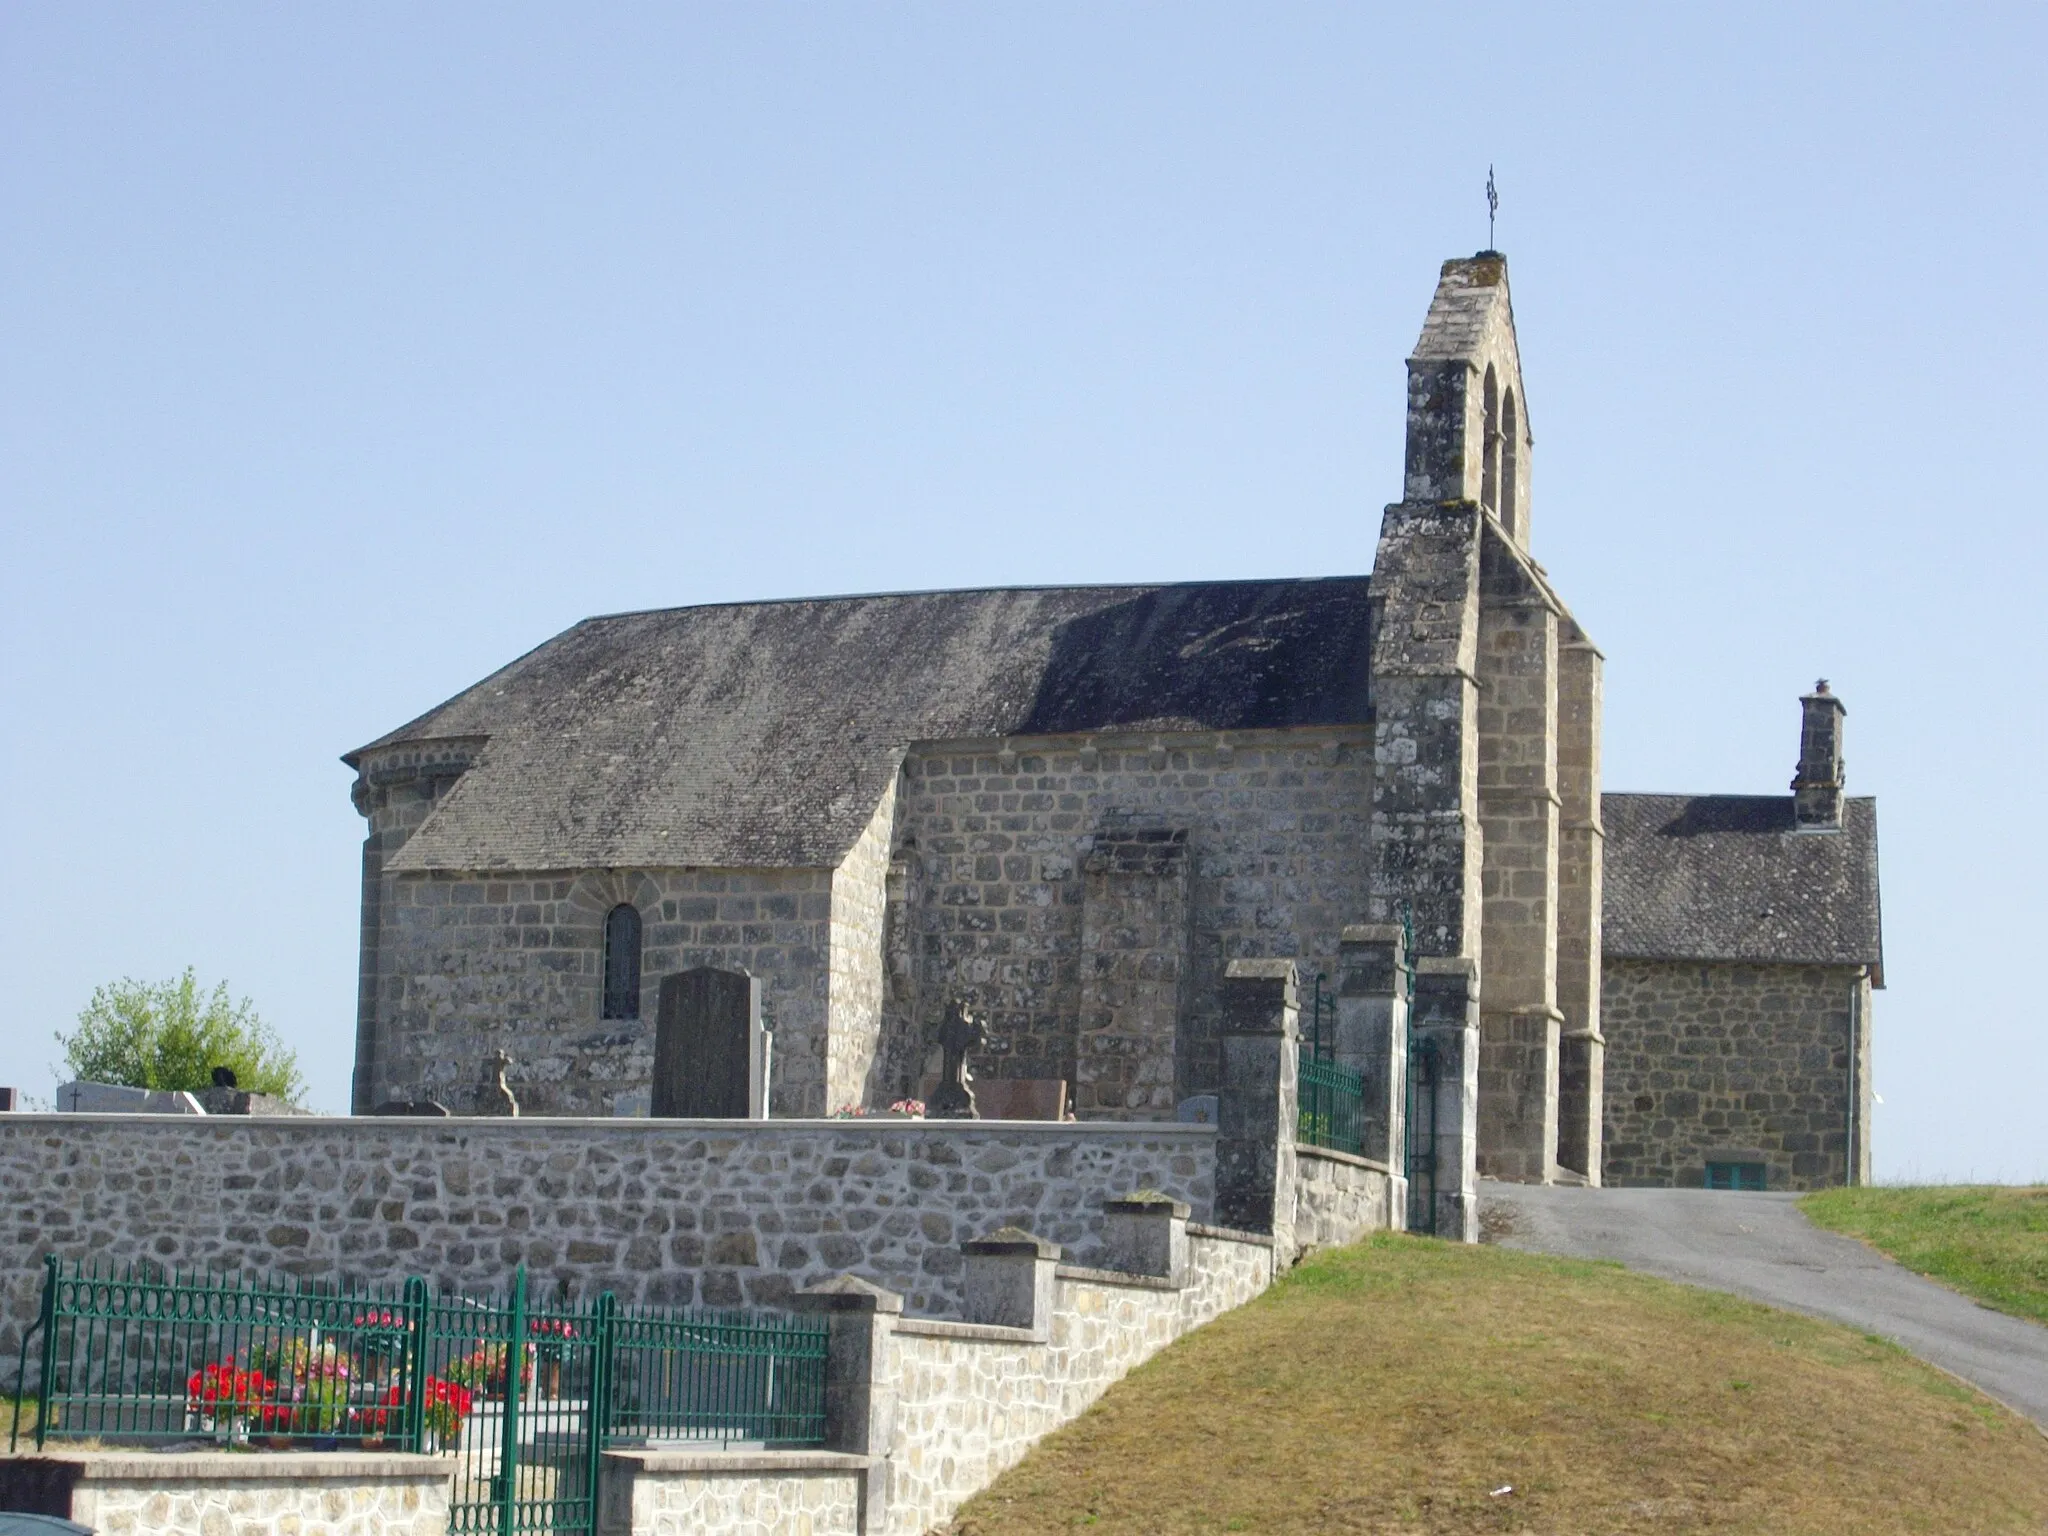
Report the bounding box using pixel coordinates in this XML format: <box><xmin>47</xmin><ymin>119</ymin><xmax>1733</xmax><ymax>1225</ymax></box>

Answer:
<box><xmin>57</xmin><ymin>969</ymin><xmax>305</xmax><ymax>1100</ymax></box>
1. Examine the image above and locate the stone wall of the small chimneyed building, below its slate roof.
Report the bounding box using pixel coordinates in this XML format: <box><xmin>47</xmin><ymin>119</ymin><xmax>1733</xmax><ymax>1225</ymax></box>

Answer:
<box><xmin>1599</xmin><ymin>956</ymin><xmax>1862</xmax><ymax>1190</ymax></box>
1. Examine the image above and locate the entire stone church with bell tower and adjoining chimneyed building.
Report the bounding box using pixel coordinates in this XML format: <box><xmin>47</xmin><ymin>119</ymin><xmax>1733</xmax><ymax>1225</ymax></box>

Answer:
<box><xmin>344</xmin><ymin>252</ymin><xmax>1882</xmax><ymax>1233</ymax></box>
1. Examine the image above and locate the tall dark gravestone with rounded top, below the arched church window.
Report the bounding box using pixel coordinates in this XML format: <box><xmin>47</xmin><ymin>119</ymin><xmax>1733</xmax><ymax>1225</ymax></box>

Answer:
<box><xmin>651</xmin><ymin>965</ymin><xmax>768</xmax><ymax>1120</ymax></box>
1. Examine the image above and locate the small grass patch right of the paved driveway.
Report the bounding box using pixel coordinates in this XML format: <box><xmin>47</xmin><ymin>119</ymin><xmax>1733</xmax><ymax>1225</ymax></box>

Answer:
<box><xmin>1798</xmin><ymin>1184</ymin><xmax>2048</xmax><ymax>1323</ymax></box>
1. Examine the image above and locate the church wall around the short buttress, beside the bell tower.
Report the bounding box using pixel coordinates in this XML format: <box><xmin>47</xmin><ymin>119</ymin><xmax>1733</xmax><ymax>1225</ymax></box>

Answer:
<box><xmin>887</xmin><ymin>727</ymin><xmax>1372</xmax><ymax>1114</ymax></box>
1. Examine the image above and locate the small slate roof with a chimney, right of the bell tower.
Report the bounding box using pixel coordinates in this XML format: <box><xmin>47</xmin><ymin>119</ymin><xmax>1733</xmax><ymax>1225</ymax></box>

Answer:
<box><xmin>1599</xmin><ymin>795</ymin><xmax>1884</xmax><ymax>985</ymax></box>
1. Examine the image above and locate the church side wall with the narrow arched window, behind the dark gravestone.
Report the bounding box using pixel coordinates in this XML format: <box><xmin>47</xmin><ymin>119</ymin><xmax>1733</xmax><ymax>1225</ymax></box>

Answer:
<box><xmin>373</xmin><ymin>870</ymin><xmax>834</xmax><ymax>1114</ymax></box>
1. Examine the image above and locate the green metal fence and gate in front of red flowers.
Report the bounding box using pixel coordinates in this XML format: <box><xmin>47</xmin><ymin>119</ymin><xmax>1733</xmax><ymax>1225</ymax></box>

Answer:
<box><xmin>8</xmin><ymin>1255</ymin><xmax>825</xmax><ymax>1536</ymax></box>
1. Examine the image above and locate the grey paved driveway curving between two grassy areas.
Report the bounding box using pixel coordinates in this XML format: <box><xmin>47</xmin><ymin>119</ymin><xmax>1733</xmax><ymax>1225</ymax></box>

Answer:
<box><xmin>1479</xmin><ymin>1180</ymin><xmax>2048</xmax><ymax>1430</ymax></box>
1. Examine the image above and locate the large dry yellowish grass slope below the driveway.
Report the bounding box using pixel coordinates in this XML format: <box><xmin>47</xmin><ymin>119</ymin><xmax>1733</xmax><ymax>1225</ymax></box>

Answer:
<box><xmin>937</xmin><ymin>1235</ymin><xmax>2048</xmax><ymax>1536</ymax></box>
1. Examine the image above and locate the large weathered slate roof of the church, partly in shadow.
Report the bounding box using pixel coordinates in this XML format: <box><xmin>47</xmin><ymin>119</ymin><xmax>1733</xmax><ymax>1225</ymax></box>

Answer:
<box><xmin>344</xmin><ymin>575</ymin><xmax>1372</xmax><ymax>870</ymax></box>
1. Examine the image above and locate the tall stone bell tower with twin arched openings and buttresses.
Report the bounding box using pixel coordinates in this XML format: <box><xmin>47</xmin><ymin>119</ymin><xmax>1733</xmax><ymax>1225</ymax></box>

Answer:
<box><xmin>1372</xmin><ymin>250</ymin><xmax>1606</xmax><ymax>1235</ymax></box>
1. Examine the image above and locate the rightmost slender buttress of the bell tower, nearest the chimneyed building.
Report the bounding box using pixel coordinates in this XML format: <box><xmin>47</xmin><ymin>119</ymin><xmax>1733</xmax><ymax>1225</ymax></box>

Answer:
<box><xmin>1556</xmin><ymin>621</ymin><xmax>1608</xmax><ymax>1188</ymax></box>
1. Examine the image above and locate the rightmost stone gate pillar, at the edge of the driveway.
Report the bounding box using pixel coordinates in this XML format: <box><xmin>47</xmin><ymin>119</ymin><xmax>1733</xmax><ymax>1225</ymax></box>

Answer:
<box><xmin>1409</xmin><ymin>954</ymin><xmax>1479</xmax><ymax>1243</ymax></box>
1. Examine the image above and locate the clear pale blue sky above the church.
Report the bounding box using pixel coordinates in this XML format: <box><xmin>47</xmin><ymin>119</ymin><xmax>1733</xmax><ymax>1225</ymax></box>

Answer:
<box><xmin>0</xmin><ymin>0</ymin><xmax>2048</xmax><ymax>1178</ymax></box>
